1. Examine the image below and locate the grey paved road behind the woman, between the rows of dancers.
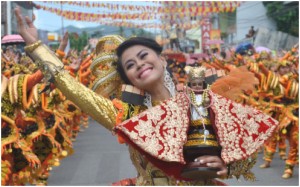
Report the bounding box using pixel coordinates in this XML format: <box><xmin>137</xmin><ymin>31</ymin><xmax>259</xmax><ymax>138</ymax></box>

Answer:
<box><xmin>48</xmin><ymin>120</ymin><xmax>299</xmax><ymax>186</ymax></box>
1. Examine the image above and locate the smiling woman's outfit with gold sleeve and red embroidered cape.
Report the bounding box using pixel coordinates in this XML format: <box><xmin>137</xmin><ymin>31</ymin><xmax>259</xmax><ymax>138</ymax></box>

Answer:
<box><xmin>22</xmin><ymin>38</ymin><xmax>277</xmax><ymax>185</ymax></box>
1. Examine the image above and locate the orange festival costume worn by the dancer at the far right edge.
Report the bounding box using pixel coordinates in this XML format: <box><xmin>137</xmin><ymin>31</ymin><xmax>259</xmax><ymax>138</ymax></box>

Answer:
<box><xmin>253</xmin><ymin>60</ymin><xmax>299</xmax><ymax>178</ymax></box>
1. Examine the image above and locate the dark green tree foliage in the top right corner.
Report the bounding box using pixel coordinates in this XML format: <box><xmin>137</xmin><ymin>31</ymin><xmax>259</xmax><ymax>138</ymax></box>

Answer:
<box><xmin>263</xmin><ymin>1</ymin><xmax>299</xmax><ymax>37</ymax></box>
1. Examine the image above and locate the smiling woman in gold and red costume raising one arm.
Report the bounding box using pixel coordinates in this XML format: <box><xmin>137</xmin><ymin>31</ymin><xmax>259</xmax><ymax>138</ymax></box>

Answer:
<box><xmin>15</xmin><ymin>5</ymin><xmax>276</xmax><ymax>186</ymax></box>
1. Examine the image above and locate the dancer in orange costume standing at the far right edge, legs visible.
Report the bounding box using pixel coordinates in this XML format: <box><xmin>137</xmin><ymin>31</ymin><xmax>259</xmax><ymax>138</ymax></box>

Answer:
<box><xmin>260</xmin><ymin>46</ymin><xmax>298</xmax><ymax>179</ymax></box>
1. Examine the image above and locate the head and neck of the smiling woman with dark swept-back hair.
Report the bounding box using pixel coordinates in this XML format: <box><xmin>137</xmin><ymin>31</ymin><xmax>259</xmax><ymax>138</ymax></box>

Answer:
<box><xmin>117</xmin><ymin>37</ymin><xmax>171</xmax><ymax>101</ymax></box>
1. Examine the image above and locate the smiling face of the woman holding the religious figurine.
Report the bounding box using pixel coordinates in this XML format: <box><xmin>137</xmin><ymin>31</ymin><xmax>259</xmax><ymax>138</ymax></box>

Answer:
<box><xmin>121</xmin><ymin>45</ymin><xmax>167</xmax><ymax>90</ymax></box>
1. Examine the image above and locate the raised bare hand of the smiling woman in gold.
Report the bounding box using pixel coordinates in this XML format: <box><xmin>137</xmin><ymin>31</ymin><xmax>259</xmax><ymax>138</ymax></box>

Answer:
<box><xmin>14</xmin><ymin>7</ymin><xmax>38</xmax><ymax>45</ymax></box>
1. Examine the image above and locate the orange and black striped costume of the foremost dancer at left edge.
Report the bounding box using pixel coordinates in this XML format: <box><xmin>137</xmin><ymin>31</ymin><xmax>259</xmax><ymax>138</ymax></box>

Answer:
<box><xmin>1</xmin><ymin>71</ymin><xmax>42</xmax><ymax>185</ymax></box>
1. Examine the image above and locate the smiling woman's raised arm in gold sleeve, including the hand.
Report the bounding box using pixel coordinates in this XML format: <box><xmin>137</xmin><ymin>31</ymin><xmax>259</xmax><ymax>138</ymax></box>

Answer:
<box><xmin>15</xmin><ymin>7</ymin><xmax>116</xmax><ymax>130</ymax></box>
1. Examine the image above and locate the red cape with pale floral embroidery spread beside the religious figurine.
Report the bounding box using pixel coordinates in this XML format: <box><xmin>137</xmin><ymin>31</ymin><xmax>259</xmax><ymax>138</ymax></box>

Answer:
<box><xmin>114</xmin><ymin>92</ymin><xmax>278</xmax><ymax>178</ymax></box>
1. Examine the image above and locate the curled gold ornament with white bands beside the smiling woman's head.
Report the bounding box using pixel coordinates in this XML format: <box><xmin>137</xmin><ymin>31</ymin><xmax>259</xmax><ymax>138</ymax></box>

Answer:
<box><xmin>90</xmin><ymin>35</ymin><xmax>125</xmax><ymax>97</ymax></box>
